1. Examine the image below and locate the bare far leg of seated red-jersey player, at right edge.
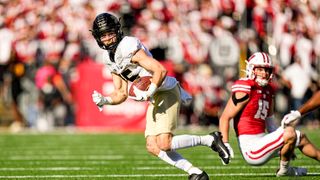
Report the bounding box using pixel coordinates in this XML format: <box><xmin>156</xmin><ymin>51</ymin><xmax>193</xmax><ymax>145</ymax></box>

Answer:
<box><xmin>298</xmin><ymin>133</ymin><xmax>320</xmax><ymax>161</ymax></box>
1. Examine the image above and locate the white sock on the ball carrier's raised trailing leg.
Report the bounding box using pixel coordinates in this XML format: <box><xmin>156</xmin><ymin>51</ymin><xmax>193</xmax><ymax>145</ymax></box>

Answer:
<box><xmin>171</xmin><ymin>135</ymin><xmax>213</xmax><ymax>150</ymax></box>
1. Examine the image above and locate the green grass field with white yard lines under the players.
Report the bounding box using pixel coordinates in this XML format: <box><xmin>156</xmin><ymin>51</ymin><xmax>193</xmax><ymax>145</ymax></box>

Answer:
<box><xmin>0</xmin><ymin>130</ymin><xmax>320</xmax><ymax>180</ymax></box>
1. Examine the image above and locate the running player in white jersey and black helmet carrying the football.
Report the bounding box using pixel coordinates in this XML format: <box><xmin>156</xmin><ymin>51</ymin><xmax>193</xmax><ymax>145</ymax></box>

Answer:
<box><xmin>91</xmin><ymin>13</ymin><xmax>230</xmax><ymax>180</ymax></box>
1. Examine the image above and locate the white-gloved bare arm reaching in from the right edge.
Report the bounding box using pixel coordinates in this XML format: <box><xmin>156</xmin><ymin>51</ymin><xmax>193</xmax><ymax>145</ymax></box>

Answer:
<box><xmin>281</xmin><ymin>91</ymin><xmax>320</xmax><ymax>126</ymax></box>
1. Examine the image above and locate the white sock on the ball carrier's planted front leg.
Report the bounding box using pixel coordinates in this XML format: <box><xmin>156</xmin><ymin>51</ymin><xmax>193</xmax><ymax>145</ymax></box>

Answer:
<box><xmin>158</xmin><ymin>151</ymin><xmax>202</xmax><ymax>174</ymax></box>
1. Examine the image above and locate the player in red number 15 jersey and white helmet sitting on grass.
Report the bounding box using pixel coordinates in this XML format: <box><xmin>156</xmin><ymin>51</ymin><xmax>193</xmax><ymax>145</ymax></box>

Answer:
<box><xmin>219</xmin><ymin>52</ymin><xmax>320</xmax><ymax>176</ymax></box>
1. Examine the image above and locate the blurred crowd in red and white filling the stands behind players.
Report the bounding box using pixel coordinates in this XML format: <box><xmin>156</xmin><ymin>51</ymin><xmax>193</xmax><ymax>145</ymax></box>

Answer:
<box><xmin>0</xmin><ymin>0</ymin><xmax>320</xmax><ymax>131</ymax></box>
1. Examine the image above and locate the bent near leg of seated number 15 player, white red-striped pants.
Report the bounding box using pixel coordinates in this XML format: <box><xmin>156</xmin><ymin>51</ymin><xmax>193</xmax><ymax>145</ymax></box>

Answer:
<box><xmin>238</xmin><ymin>127</ymin><xmax>306</xmax><ymax>176</ymax></box>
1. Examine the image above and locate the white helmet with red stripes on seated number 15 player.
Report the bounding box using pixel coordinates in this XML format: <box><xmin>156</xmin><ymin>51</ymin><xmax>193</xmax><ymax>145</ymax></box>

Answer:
<box><xmin>246</xmin><ymin>52</ymin><xmax>274</xmax><ymax>86</ymax></box>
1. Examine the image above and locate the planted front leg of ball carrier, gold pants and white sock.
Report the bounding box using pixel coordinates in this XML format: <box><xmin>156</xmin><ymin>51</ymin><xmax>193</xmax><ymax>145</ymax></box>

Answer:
<box><xmin>145</xmin><ymin>87</ymin><xmax>209</xmax><ymax>179</ymax></box>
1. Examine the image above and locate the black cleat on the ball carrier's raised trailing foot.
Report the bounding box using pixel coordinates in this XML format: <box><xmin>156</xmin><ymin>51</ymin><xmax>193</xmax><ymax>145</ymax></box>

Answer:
<box><xmin>210</xmin><ymin>131</ymin><xmax>231</xmax><ymax>165</ymax></box>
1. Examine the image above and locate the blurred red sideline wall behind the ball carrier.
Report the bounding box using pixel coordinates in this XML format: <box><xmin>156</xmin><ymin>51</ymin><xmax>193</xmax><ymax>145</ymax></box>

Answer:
<box><xmin>71</xmin><ymin>60</ymin><xmax>147</xmax><ymax>131</ymax></box>
